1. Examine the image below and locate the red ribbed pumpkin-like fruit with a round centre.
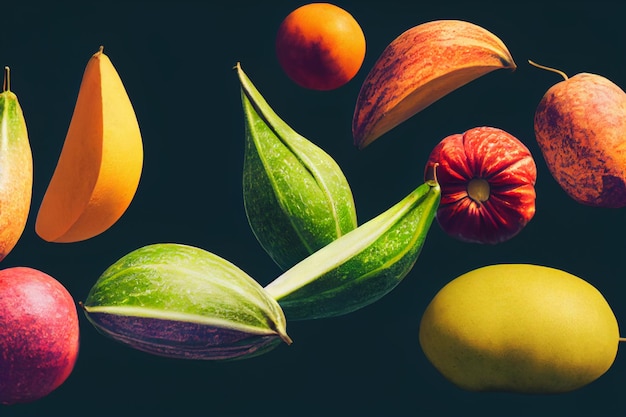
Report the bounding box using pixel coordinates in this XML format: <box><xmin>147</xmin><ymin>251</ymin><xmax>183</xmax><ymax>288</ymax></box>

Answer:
<box><xmin>425</xmin><ymin>127</ymin><xmax>537</xmax><ymax>244</ymax></box>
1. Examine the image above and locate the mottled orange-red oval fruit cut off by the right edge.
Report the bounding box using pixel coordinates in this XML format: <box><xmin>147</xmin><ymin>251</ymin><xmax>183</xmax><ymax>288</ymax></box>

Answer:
<box><xmin>534</xmin><ymin>73</ymin><xmax>626</xmax><ymax>208</ymax></box>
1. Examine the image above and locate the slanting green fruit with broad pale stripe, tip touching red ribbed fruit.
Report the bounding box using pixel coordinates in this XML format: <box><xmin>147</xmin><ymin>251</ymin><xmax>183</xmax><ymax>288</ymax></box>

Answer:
<box><xmin>265</xmin><ymin>181</ymin><xmax>441</xmax><ymax>320</ymax></box>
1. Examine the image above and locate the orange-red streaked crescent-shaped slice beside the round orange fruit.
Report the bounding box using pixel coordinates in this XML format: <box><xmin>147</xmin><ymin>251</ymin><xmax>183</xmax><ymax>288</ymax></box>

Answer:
<box><xmin>352</xmin><ymin>20</ymin><xmax>516</xmax><ymax>149</ymax></box>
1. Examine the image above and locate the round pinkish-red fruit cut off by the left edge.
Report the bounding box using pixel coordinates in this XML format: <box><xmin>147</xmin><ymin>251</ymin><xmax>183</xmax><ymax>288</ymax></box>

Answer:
<box><xmin>0</xmin><ymin>267</ymin><xmax>79</xmax><ymax>404</ymax></box>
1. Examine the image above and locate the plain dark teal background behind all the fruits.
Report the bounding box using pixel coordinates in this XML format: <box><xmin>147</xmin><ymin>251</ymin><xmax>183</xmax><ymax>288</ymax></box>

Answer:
<box><xmin>0</xmin><ymin>0</ymin><xmax>626</xmax><ymax>417</ymax></box>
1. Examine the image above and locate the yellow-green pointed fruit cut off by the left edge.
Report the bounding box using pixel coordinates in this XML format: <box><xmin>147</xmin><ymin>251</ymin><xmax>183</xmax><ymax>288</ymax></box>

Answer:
<box><xmin>0</xmin><ymin>67</ymin><xmax>33</xmax><ymax>260</ymax></box>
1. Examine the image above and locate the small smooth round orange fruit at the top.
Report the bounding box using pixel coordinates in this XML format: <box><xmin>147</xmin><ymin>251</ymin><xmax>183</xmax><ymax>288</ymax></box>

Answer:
<box><xmin>276</xmin><ymin>3</ymin><xmax>365</xmax><ymax>91</ymax></box>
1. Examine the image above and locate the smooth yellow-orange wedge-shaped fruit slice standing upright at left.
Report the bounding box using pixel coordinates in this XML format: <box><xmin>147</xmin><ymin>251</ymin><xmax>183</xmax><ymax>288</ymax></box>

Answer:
<box><xmin>35</xmin><ymin>47</ymin><xmax>143</xmax><ymax>243</ymax></box>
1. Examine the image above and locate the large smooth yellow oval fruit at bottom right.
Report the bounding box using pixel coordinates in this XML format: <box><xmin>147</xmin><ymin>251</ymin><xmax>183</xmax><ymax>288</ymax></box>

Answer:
<box><xmin>419</xmin><ymin>264</ymin><xmax>619</xmax><ymax>393</ymax></box>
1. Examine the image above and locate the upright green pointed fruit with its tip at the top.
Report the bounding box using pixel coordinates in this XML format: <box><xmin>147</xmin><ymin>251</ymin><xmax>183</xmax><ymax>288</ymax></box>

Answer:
<box><xmin>235</xmin><ymin>64</ymin><xmax>357</xmax><ymax>270</ymax></box>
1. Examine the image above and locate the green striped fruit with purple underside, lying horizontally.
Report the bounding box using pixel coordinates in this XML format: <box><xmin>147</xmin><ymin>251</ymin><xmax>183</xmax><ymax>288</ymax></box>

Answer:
<box><xmin>82</xmin><ymin>243</ymin><xmax>291</xmax><ymax>360</ymax></box>
